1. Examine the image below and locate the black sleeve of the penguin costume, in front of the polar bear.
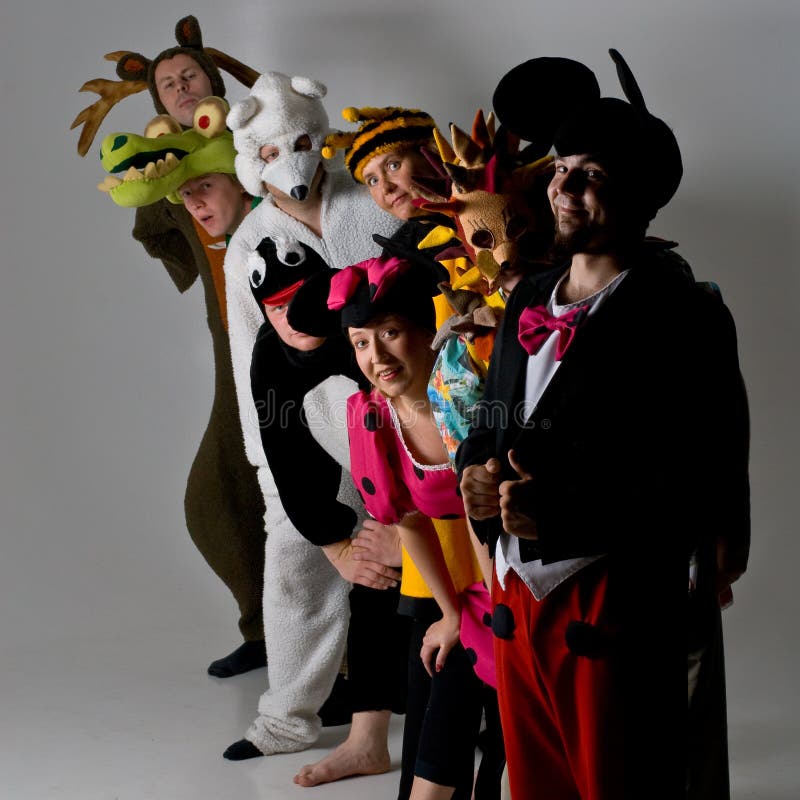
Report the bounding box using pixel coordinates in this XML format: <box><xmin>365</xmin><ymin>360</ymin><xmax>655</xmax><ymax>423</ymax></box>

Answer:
<box><xmin>250</xmin><ymin>323</ymin><xmax>357</xmax><ymax>546</ymax></box>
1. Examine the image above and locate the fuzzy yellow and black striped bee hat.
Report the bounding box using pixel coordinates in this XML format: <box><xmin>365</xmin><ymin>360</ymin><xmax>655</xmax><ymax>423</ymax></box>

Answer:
<box><xmin>322</xmin><ymin>106</ymin><xmax>436</xmax><ymax>183</ymax></box>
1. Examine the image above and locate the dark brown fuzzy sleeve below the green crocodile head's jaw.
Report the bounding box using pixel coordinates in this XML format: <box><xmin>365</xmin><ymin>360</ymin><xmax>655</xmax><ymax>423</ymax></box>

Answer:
<box><xmin>133</xmin><ymin>199</ymin><xmax>198</xmax><ymax>292</ymax></box>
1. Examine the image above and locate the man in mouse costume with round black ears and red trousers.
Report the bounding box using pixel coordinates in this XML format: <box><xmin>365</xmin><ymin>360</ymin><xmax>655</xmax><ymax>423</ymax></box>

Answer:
<box><xmin>458</xmin><ymin>50</ymin><xmax>750</xmax><ymax>800</ymax></box>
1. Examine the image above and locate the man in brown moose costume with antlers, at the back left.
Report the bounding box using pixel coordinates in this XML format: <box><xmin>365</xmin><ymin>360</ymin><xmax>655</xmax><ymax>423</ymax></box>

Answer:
<box><xmin>72</xmin><ymin>16</ymin><xmax>266</xmax><ymax>678</ymax></box>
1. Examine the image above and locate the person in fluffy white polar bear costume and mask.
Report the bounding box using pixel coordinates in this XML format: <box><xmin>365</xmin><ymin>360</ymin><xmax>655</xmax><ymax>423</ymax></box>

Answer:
<box><xmin>225</xmin><ymin>72</ymin><xmax>399</xmax><ymax>760</ymax></box>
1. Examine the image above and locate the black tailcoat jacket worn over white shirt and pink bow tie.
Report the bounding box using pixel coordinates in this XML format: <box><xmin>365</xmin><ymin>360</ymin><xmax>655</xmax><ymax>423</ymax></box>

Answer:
<box><xmin>457</xmin><ymin>250</ymin><xmax>750</xmax><ymax>576</ymax></box>
